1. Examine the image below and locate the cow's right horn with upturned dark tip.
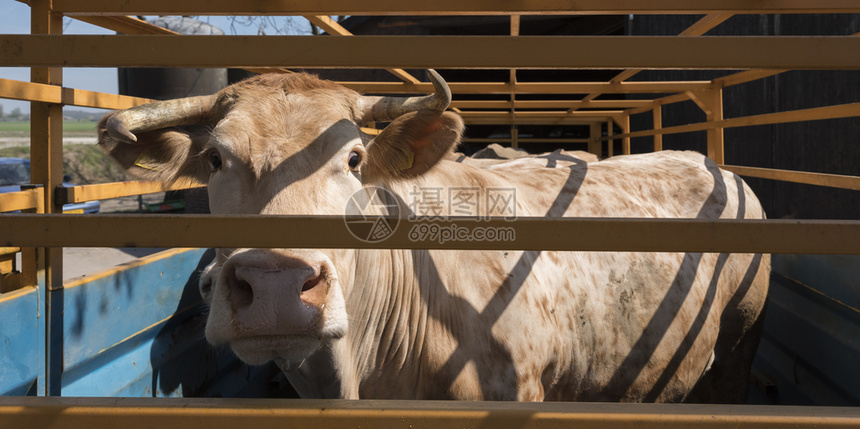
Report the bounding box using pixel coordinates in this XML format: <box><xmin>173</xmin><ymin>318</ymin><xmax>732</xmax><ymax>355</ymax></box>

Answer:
<box><xmin>360</xmin><ymin>69</ymin><xmax>451</xmax><ymax>122</ymax></box>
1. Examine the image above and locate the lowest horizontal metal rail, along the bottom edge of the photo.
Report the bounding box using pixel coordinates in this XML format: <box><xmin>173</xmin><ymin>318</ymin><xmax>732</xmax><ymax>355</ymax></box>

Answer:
<box><xmin>0</xmin><ymin>397</ymin><xmax>860</xmax><ymax>429</ymax></box>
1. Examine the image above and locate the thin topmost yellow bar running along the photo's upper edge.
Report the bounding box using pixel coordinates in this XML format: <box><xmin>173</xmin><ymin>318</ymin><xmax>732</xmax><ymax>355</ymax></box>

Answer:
<box><xmin>48</xmin><ymin>0</ymin><xmax>860</xmax><ymax>15</ymax></box>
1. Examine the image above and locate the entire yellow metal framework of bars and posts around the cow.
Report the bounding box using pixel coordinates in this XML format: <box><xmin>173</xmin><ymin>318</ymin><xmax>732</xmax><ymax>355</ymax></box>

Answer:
<box><xmin>0</xmin><ymin>0</ymin><xmax>860</xmax><ymax>427</ymax></box>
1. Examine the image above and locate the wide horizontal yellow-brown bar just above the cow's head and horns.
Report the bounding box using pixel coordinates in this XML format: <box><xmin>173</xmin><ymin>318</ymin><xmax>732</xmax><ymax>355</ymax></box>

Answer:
<box><xmin>6</xmin><ymin>35</ymin><xmax>860</xmax><ymax>70</ymax></box>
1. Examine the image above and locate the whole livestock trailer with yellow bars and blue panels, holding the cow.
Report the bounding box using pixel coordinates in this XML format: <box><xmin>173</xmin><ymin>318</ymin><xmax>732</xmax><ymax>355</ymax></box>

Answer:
<box><xmin>0</xmin><ymin>0</ymin><xmax>860</xmax><ymax>427</ymax></box>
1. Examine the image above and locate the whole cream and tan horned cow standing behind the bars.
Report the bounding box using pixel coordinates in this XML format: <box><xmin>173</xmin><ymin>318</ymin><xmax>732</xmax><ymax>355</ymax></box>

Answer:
<box><xmin>98</xmin><ymin>71</ymin><xmax>770</xmax><ymax>402</ymax></box>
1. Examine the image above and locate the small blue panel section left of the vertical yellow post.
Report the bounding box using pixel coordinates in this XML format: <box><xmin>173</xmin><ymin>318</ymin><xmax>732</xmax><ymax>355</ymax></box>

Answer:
<box><xmin>0</xmin><ymin>288</ymin><xmax>39</xmax><ymax>395</ymax></box>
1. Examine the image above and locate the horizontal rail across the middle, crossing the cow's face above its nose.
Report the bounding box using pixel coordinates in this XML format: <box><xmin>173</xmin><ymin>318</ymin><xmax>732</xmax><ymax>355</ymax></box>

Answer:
<box><xmin>0</xmin><ymin>214</ymin><xmax>860</xmax><ymax>255</ymax></box>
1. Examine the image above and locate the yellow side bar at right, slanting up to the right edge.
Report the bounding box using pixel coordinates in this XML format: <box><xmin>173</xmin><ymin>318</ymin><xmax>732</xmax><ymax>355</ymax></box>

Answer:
<box><xmin>603</xmin><ymin>103</ymin><xmax>860</xmax><ymax>140</ymax></box>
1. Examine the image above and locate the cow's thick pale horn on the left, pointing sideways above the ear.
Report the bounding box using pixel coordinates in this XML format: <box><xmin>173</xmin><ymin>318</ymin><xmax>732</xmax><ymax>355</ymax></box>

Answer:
<box><xmin>105</xmin><ymin>95</ymin><xmax>215</xmax><ymax>143</ymax></box>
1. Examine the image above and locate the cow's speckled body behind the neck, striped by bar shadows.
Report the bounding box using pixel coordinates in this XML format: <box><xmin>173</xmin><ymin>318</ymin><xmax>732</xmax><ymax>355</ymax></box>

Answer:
<box><xmin>352</xmin><ymin>152</ymin><xmax>769</xmax><ymax>401</ymax></box>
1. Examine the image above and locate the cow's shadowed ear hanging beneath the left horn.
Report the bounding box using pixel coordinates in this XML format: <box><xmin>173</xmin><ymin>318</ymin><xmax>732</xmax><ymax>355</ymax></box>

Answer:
<box><xmin>98</xmin><ymin>115</ymin><xmax>209</xmax><ymax>184</ymax></box>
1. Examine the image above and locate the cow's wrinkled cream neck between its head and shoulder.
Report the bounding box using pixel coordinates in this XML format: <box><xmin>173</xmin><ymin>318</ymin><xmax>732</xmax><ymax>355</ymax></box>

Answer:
<box><xmin>333</xmin><ymin>163</ymin><xmax>520</xmax><ymax>399</ymax></box>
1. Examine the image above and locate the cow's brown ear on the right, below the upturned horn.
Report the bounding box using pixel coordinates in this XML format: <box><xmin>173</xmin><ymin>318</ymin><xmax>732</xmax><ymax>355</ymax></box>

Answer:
<box><xmin>361</xmin><ymin>110</ymin><xmax>463</xmax><ymax>182</ymax></box>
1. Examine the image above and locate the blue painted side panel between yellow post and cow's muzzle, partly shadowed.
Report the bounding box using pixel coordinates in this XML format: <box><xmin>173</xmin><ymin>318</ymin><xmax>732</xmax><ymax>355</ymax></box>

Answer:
<box><xmin>62</xmin><ymin>247</ymin><xmax>295</xmax><ymax>397</ymax></box>
